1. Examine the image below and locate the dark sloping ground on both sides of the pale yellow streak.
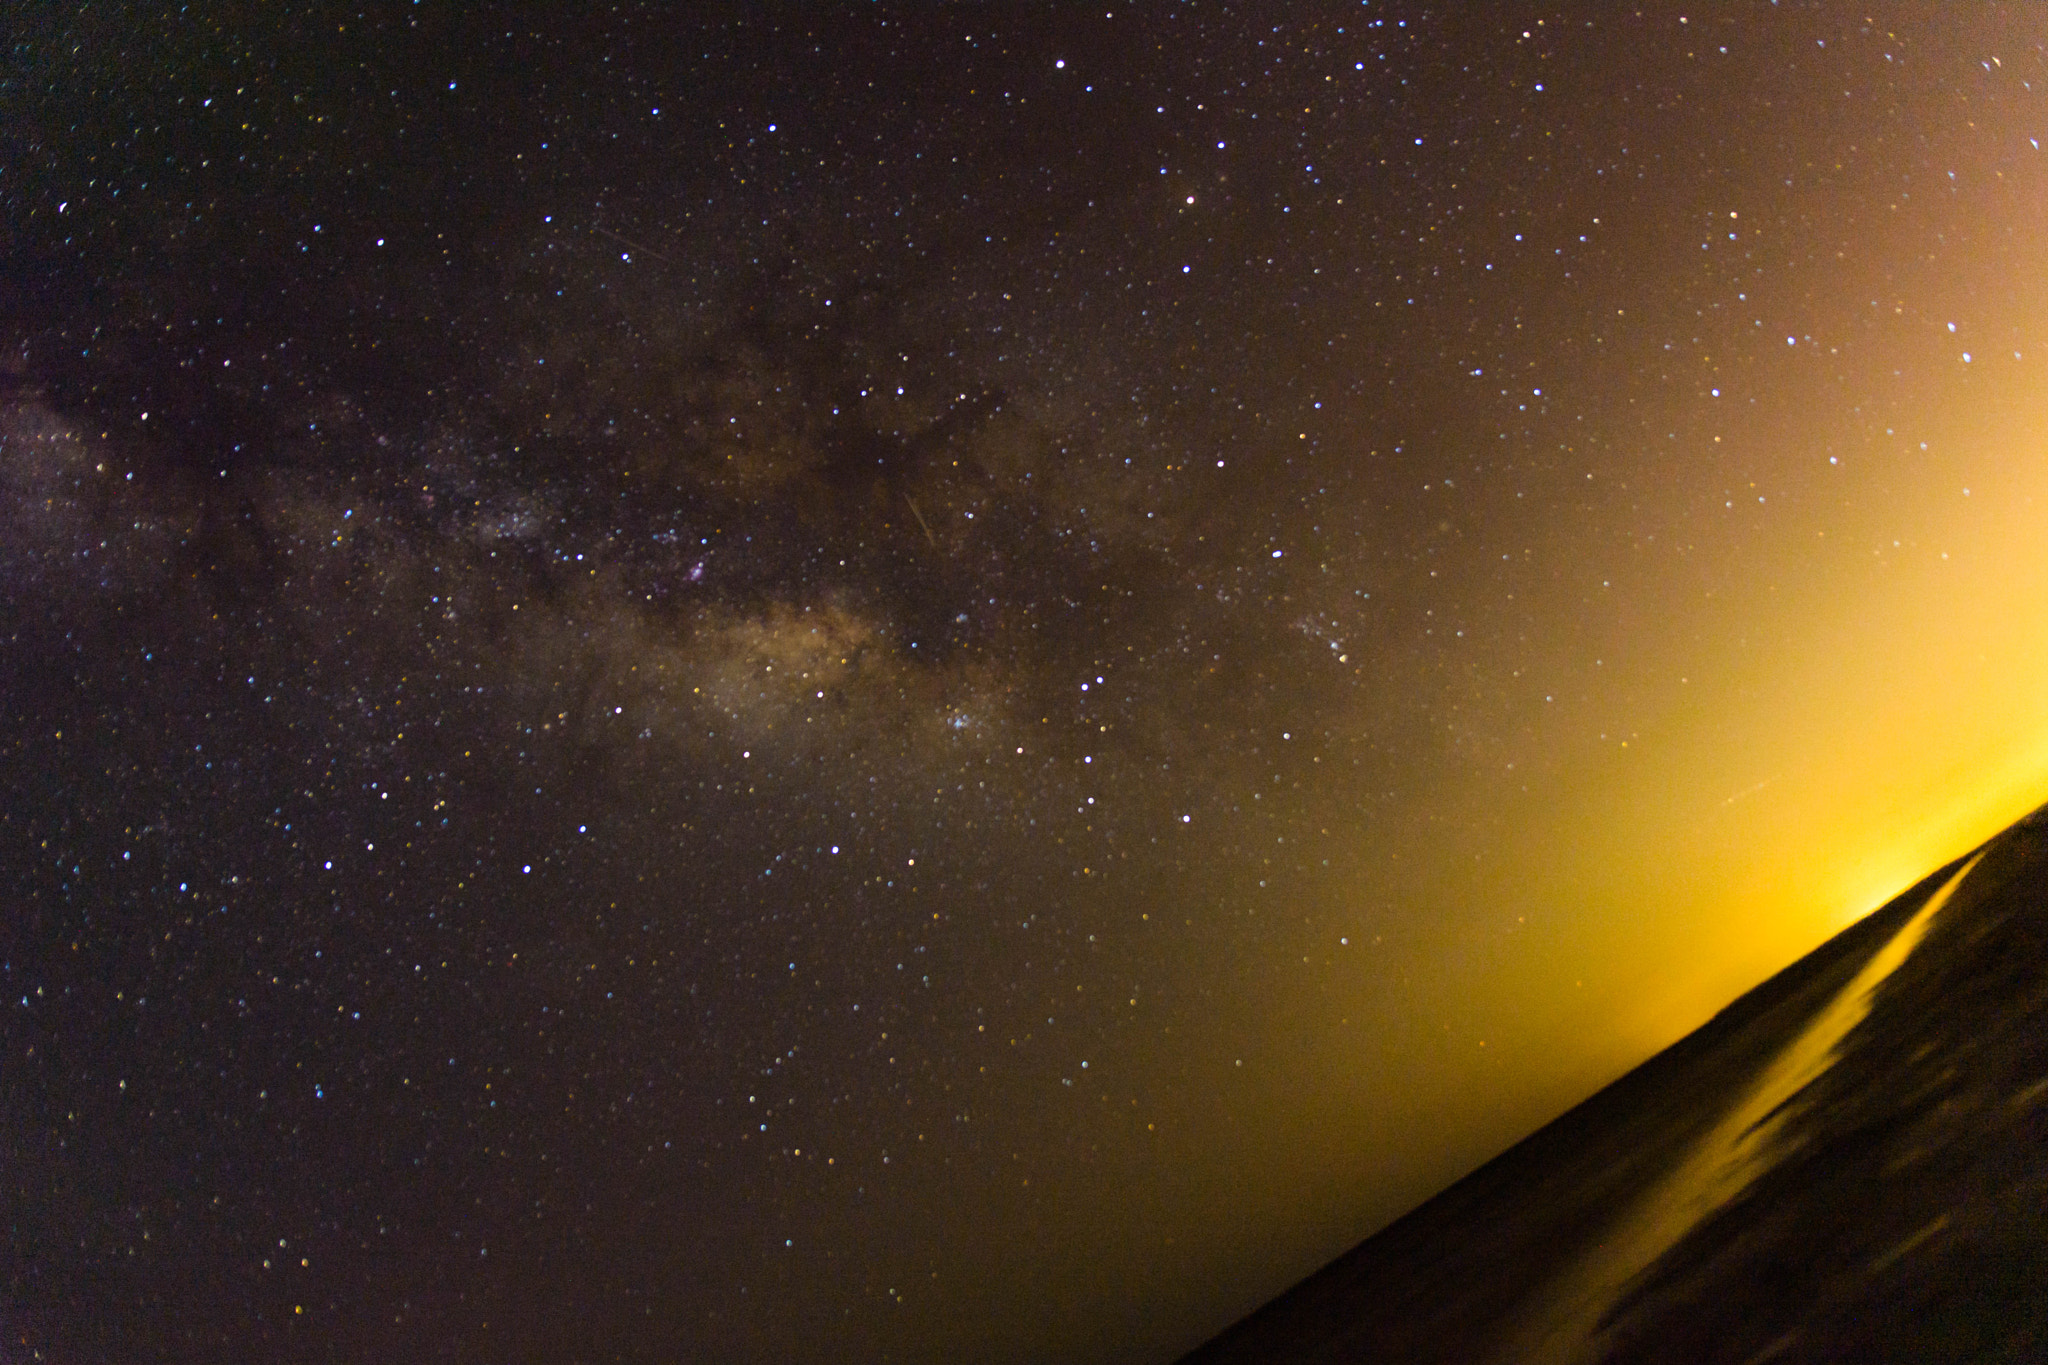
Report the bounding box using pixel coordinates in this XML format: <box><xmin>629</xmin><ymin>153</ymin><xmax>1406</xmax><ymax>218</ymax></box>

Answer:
<box><xmin>1184</xmin><ymin>812</ymin><xmax>2048</xmax><ymax>1365</ymax></box>
